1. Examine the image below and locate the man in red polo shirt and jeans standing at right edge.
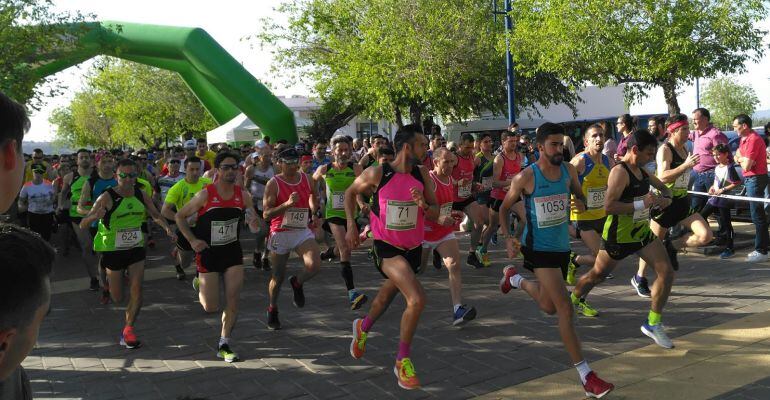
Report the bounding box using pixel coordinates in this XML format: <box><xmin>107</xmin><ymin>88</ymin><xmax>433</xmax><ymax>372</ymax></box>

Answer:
<box><xmin>733</xmin><ymin>114</ymin><xmax>770</xmax><ymax>262</ymax></box>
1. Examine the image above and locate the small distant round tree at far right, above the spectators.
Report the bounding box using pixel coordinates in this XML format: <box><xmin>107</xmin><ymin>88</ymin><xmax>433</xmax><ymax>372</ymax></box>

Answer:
<box><xmin>701</xmin><ymin>78</ymin><xmax>759</xmax><ymax>130</ymax></box>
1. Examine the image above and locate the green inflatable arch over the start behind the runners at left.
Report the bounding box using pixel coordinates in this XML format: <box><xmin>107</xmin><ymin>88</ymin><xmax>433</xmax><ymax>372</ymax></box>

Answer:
<box><xmin>34</xmin><ymin>21</ymin><xmax>297</xmax><ymax>144</ymax></box>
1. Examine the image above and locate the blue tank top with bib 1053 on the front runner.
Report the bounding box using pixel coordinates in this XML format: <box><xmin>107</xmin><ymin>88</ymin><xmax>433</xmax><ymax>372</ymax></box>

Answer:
<box><xmin>524</xmin><ymin>163</ymin><xmax>570</xmax><ymax>252</ymax></box>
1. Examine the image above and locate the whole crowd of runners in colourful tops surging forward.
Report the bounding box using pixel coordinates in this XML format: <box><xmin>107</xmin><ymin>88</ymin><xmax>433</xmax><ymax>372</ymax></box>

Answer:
<box><xmin>7</xmin><ymin>102</ymin><xmax>768</xmax><ymax>398</ymax></box>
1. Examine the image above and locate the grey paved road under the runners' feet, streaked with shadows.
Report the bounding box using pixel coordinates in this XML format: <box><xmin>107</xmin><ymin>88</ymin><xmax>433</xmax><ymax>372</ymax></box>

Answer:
<box><xmin>24</xmin><ymin>223</ymin><xmax>770</xmax><ymax>399</ymax></box>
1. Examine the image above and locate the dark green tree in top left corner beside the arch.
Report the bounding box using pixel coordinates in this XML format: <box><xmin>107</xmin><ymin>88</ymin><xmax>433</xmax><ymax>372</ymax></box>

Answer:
<box><xmin>0</xmin><ymin>0</ymin><xmax>91</xmax><ymax>108</ymax></box>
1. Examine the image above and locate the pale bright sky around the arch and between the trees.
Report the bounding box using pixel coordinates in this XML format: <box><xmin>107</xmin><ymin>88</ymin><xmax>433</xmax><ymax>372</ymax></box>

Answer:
<box><xmin>25</xmin><ymin>0</ymin><xmax>770</xmax><ymax>141</ymax></box>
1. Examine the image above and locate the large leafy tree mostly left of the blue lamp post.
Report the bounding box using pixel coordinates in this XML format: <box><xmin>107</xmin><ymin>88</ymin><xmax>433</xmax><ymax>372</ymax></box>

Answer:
<box><xmin>257</xmin><ymin>0</ymin><xmax>577</xmax><ymax>126</ymax></box>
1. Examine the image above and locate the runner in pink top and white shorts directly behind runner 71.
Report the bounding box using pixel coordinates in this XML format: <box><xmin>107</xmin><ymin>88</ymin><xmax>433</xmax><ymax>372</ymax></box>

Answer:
<box><xmin>422</xmin><ymin>148</ymin><xmax>476</xmax><ymax>325</ymax></box>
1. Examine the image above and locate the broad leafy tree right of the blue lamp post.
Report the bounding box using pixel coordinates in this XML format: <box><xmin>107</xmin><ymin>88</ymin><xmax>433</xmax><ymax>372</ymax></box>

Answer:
<box><xmin>511</xmin><ymin>0</ymin><xmax>767</xmax><ymax>114</ymax></box>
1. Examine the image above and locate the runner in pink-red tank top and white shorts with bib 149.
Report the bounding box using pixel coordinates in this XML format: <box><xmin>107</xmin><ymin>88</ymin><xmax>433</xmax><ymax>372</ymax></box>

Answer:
<box><xmin>264</xmin><ymin>148</ymin><xmax>321</xmax><ymax>330</ymax></box>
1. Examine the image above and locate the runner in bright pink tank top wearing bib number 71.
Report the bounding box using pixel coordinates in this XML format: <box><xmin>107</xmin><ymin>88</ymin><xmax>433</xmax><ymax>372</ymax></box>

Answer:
<box><xmin>345</xmin><ymin>124</ymin><xmax>439</xmax><ymax>389</ymax></box>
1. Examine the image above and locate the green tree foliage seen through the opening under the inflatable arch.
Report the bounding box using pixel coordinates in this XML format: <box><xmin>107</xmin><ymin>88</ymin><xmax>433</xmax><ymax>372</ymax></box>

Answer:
<box><xmin>51</xmin><ymin>58</ymin><xmax>216</xmax><ymax>151</ymax></box>
